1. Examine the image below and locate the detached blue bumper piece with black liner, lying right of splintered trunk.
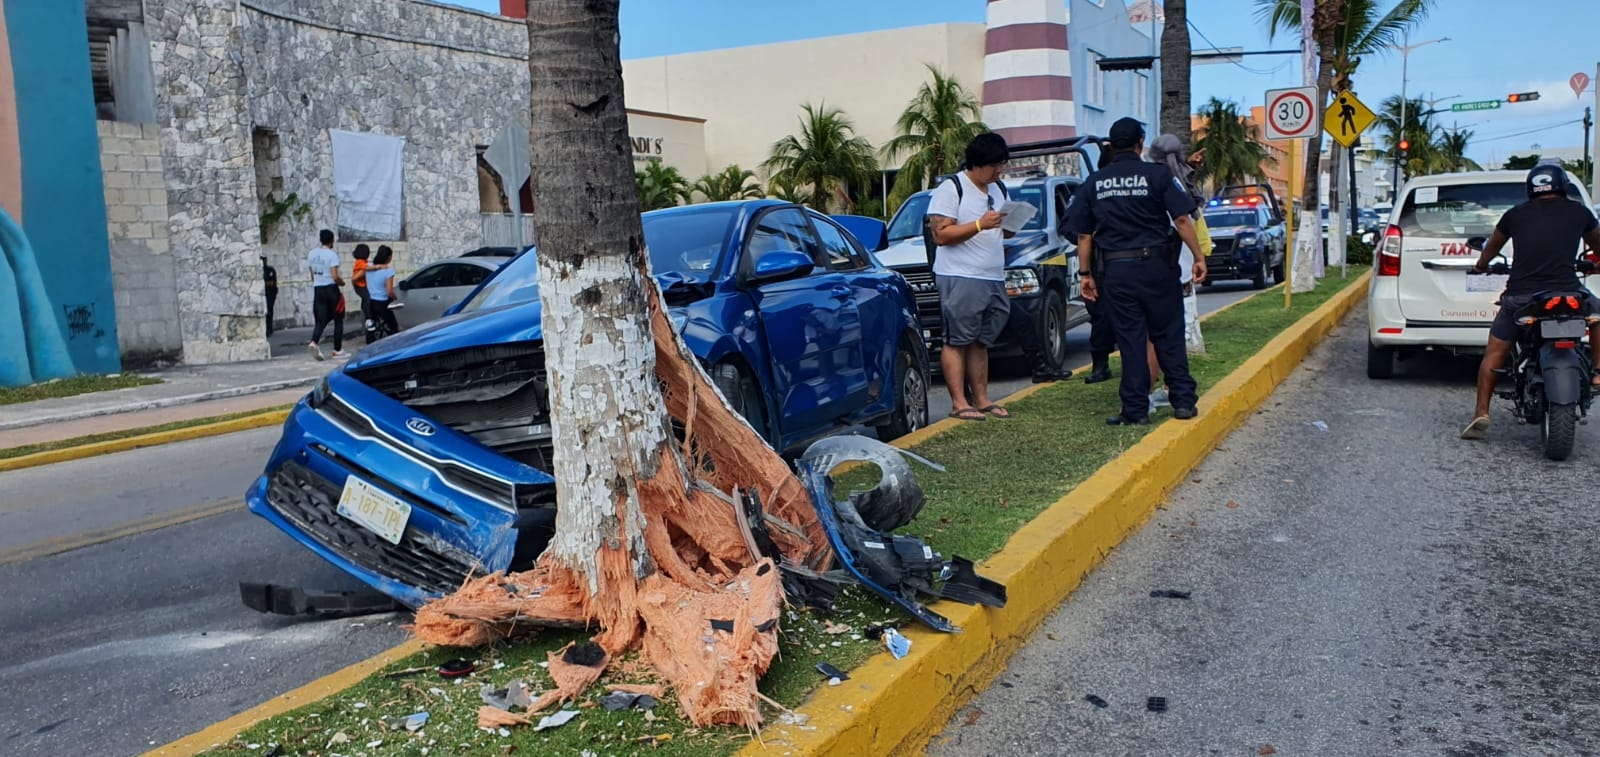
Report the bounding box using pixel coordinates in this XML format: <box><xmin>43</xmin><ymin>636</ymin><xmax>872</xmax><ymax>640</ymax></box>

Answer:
<box><xmin>795</xmin><ymin>437</ymin><xmax>1006</xmax><ymax>632</ymax></box>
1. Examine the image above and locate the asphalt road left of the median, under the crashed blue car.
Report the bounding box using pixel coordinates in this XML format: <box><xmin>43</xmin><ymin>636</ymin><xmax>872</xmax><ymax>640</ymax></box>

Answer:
<box><xmin>0</xmin><ymin>283</ymin><xmax>1250</xmax><ymax>755</ymax></box>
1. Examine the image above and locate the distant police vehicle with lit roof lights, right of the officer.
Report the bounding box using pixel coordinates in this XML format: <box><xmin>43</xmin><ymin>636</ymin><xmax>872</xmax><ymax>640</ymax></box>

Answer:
<box><xmin>1205</xmin><ymin>195</ymin><xmax>1288</xmax><ymax>290</ymax></box>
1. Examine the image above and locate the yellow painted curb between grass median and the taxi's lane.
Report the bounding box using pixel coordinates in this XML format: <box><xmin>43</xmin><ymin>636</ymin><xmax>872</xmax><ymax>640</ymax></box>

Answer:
<box><xmin>738</xmin><ymin>274</ymin><xmax>1371</xmax><ymax>757</ymax></box>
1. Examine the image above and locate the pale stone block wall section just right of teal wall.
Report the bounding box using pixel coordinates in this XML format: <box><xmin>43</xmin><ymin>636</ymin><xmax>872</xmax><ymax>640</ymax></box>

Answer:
<box><xmin>96</xmin><ymin>122</ymin><xmax>184</xmax><ymax>370</ymax></box>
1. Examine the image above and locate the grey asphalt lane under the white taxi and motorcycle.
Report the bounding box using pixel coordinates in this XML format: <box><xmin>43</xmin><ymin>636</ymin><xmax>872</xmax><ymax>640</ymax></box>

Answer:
<box><xmin>930</xmin><ymin>310</ymin><xmax>1600</xmax><ymax>757</ymax></box>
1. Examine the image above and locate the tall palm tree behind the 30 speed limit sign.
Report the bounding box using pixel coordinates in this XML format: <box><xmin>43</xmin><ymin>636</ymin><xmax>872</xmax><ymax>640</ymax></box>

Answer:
<box><xmin>1256</xmin><ymin>0</ymin><xmax>1434</xmax><ymax>208</ymax></box>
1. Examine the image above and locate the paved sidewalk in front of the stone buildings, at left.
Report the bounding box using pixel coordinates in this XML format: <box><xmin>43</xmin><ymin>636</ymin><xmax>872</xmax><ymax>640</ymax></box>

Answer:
<box><xmin>0</xmin><ymin>323</ymin><xmax>363</xmax><ymax>450</ymax></box>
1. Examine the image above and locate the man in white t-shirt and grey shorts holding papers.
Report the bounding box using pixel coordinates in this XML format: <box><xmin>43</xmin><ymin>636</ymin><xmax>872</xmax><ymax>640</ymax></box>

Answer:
<box><xmin>928</xmin><ymin>133</ymin><xmax>1011</xmax><ymax>421</ymax></box>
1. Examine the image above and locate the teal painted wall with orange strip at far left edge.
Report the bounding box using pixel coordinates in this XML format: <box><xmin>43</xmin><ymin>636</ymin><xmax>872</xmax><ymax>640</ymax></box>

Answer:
<box><xmin>0</xmin><ymin>0</ymin><xmax>122</xmax><ymax>386</ymax></box>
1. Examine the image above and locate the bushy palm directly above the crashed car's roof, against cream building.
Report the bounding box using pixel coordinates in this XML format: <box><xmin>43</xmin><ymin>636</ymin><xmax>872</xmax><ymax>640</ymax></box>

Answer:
<box><xmin>762</xmin><ymin>102</ymin><xmax>878</xmax><ymax>210</ymax></box>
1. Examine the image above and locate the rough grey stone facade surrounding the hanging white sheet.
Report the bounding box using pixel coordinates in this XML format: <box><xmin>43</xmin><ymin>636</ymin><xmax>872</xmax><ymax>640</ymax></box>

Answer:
<box><xmin>238</xmin><ymin>0</ymin><xmax>528</xmax><ymax>326</ymax></box>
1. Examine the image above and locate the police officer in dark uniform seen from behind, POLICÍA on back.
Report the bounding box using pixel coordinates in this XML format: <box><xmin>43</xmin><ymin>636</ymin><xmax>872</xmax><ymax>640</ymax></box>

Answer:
<box><xmin>1077</xmin><ymin>118</ymin><xmax>1205</xmax><ymax>426</ymax></box>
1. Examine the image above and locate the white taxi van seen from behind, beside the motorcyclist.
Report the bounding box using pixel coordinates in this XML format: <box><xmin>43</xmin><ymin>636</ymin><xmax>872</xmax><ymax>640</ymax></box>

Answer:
<box><xmin>1366</xmin><ymin>171</ymin><xmax>1589</xmax><ymax>379</ymax></box>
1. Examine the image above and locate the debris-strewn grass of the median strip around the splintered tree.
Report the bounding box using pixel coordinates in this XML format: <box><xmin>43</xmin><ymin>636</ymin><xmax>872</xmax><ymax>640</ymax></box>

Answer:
<box><xmin>187</xmin><ymin>272</ymin><xmax>1360</xmax><ymax>755</ymax></box>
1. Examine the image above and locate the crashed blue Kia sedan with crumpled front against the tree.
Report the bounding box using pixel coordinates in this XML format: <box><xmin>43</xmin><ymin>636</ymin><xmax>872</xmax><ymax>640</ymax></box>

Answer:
<box><xmin>246</xmin><ymin>200</ymin><xmax>928</xmax><ymax>608</ymax></box>
